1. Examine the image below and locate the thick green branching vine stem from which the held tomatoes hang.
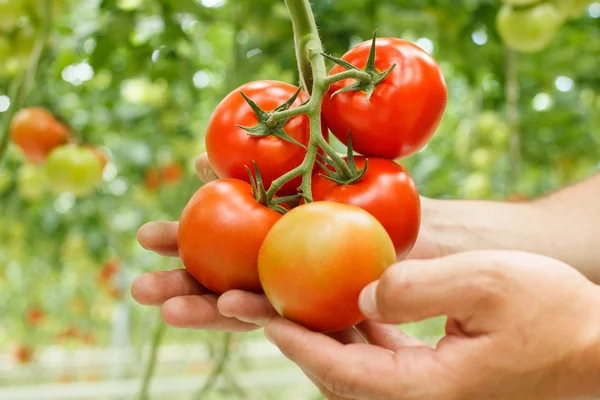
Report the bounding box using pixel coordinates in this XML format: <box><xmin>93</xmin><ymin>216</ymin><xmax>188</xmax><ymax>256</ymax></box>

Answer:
<box><xmin>267</xmin><ymin>0</ymin><xmax>354</xmax><ymax>202</ymax></box>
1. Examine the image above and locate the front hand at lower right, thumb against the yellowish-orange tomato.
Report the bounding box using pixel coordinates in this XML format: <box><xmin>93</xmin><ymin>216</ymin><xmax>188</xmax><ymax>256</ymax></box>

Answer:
<box><xmin>265</xmin><ymin>251</ymin><xmax>600</xmax><ymax>400</ymax></box>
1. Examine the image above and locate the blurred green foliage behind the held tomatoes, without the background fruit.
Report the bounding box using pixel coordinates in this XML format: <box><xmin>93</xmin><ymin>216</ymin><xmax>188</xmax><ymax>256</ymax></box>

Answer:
<box><xmin>0</xmin><ymin>0</ymin><xmax>600</xmax><ymax>390</ymax></box>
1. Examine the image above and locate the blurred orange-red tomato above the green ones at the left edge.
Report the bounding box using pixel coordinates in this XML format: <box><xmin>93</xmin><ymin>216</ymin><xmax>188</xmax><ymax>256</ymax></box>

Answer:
<box><xmin>10</xmin><ymin>107</ymin><xmax>71</xmax><ymax>164</ymax></box>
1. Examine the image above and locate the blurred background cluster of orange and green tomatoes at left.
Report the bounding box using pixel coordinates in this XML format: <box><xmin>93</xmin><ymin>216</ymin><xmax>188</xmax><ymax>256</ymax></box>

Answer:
<box><xmin>10</xmin><ymin>107</ymin><xmax>108</xmax><ymax>198</ymax></box>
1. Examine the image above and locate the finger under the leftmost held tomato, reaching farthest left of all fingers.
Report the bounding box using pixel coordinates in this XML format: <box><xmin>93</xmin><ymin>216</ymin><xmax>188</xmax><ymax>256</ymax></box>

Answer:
<box><xmin>131</xmin><ymin>269</ymin><xmax>209</xmax><ymax>306</ymax></box>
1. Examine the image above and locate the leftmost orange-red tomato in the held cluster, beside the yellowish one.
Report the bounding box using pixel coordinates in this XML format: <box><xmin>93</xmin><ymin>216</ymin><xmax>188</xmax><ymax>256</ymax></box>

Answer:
<box><xmin>177</xmin><ymin>179</ymin><xmax>281</xmax><ymax>294</ymax></box>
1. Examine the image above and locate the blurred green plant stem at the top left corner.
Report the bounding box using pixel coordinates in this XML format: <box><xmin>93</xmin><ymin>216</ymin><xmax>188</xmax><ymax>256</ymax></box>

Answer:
<box><xmin>0</xmin><ymin>0</ymin><xmax>54</xmax><ymax>166</ymax></box>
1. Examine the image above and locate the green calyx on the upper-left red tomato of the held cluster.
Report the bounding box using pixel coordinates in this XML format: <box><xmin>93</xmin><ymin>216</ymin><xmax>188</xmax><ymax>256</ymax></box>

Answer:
<box><xmin>236</xmin><ymin>88</ymin><xmax>306</xmax><ymax>148</ymax></box>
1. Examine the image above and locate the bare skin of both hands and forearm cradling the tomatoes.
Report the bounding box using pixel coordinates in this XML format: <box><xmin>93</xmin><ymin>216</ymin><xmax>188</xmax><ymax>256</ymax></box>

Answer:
<box><xmin>132</xmin><ymin>155</ymin><xmax>600</xmax><ymax>399</ymax></box>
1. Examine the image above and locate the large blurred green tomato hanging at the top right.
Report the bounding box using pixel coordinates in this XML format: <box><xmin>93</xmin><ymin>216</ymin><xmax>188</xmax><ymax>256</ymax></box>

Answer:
<box><xmin>496</xmin><ymin>3</ymin><xmax>563</xmax><ymax>53</ymax></box>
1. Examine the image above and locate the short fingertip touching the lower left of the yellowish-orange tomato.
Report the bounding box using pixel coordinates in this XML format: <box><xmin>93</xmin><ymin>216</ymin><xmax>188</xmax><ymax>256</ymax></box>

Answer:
<box><xmin>217</xmin><ymin>290</ymin><xmax>277</xmax><ymax>326</ymax></box>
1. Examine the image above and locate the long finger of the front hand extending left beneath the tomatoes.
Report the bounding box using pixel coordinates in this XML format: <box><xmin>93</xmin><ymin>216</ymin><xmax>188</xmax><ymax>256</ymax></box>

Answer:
<box><xmin>265</xmin><ymin>318</ymin><xmax>416</xmax><ymax>400</ymax></box>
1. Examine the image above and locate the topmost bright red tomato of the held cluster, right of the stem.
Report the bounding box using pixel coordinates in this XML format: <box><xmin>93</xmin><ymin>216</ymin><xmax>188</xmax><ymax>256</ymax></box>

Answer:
<box><xmin>323</xmin><ymin>38</ymin><xmax>448</xmax><ymax>159</ymax></box>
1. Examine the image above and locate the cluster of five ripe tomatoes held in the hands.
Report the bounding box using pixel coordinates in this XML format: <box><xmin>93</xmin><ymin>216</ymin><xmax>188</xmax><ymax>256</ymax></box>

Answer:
<box><xmin>178</xmin><ymin>38</ymin><xmax>448</xmax><ymax>332</ymax></box>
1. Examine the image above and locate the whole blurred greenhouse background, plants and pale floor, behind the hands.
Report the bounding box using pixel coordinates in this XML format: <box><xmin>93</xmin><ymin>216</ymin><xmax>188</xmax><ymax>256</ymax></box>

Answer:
<box><xmin>0</xmin><ymin>0</ymin><xmax>600</xmax><ymax>400</ymax></box>
